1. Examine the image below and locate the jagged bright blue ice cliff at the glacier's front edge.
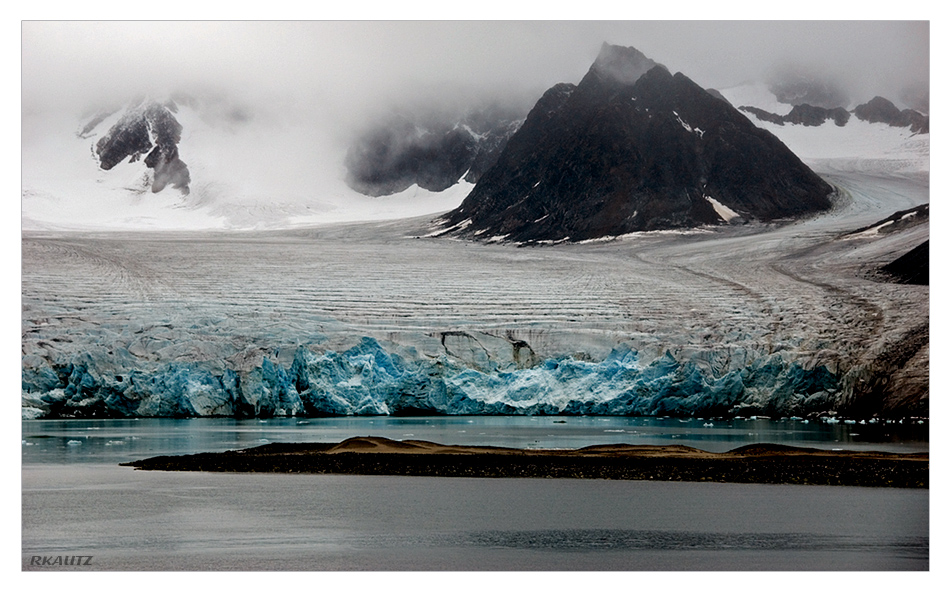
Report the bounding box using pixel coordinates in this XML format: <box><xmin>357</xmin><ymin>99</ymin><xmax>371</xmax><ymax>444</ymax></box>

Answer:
<box><xmin>22</xmin><ymin>337</ymin><xmax>838</xmax><ymax>419</ymax></box>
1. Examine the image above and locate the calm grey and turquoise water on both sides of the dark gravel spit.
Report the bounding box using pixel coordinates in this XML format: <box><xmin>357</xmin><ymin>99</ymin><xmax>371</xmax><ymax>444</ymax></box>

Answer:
<box><xmin>22</xmin><ymin>418</ymin><xmax>929</xmax><ymax>571</ymax></box>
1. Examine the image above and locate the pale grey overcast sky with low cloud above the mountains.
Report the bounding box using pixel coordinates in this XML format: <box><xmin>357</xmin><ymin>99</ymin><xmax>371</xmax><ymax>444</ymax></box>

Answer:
<box><xmin>22</xmin><ymin>21</ymin><xmax>930</xmax><ymax>119</ymax></box>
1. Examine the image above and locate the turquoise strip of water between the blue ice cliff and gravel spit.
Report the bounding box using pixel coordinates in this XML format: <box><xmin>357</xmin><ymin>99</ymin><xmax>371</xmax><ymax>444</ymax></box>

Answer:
<box><xmin>21</xmin><ymin>416</ymin><xmax>929</xmax><ymax>463</ymax></box>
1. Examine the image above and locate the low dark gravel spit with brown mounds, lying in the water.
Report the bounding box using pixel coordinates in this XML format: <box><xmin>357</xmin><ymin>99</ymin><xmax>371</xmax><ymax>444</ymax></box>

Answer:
<box><xmin>122</xmin><ymin>437</ymin><xmax>930</xmax><ymax>489</ymax></box>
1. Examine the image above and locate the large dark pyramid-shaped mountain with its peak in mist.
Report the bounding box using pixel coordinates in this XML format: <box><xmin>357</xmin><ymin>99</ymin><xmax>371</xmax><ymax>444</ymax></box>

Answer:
<box><xmin>440</xmin><ymin>44</ymin><xmax>832</xmax><ymax>243</ymax></box>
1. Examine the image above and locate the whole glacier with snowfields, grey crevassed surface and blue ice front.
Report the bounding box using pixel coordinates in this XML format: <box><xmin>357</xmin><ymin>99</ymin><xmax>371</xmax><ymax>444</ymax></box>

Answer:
<box><xmin>21</xmin><ymin>80</ymin><xmax>929</xmax><ymax>419</ymax></box>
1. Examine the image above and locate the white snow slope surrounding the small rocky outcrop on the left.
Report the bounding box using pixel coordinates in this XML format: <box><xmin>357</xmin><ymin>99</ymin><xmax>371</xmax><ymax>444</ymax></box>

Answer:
<box><xmin>22</xmin><ymin>99</ymin><xmax>471</xmax><ymax>230</ymax></box>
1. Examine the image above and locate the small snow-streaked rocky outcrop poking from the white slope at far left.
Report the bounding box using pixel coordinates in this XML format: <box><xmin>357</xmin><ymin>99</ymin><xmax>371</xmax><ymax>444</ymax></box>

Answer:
<box><xmin>79</xmin><ymin>100</ymin><xmax>191</xmax><ymax>194</ymax></box>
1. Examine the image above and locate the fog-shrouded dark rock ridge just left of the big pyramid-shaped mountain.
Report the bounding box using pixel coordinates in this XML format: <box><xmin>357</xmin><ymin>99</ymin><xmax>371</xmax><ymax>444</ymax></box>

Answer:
<box><xmin>344</xmin><ymin>105</ymin><xmax>524</xmax><ymax>196</ymax></box>
